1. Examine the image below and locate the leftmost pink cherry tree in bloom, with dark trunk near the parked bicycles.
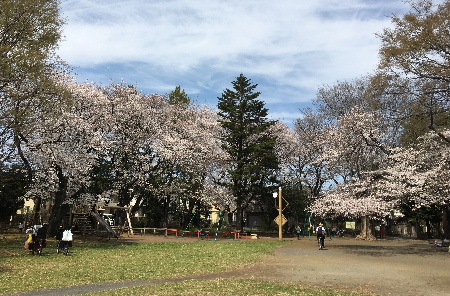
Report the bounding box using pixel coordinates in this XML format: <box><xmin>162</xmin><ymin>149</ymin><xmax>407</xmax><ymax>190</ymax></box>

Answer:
<box><xmin>25</xmin><ymin>75</ymin><xmax>106</xmax><ymax>231</ymax></box>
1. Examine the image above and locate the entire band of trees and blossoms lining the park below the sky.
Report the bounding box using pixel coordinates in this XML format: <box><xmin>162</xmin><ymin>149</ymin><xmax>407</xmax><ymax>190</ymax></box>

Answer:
<box><xmin>7</xmin><ymin>0</ymin><xmax>450</xmax><ymax>239</ymax></box>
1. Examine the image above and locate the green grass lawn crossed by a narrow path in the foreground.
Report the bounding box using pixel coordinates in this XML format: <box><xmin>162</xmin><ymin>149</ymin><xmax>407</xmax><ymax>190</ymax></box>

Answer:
<box><xmin>0</xmin><ymin>235</ymin><xmax>370</xmax><ymax>295</ymax></box>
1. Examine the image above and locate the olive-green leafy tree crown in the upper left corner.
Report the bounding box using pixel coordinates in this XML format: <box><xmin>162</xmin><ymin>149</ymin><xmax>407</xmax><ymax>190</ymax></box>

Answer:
<box><xmin>0</xmin><ymin>0</ymin><xmax>67</xmax><ymax>224</ymax></box>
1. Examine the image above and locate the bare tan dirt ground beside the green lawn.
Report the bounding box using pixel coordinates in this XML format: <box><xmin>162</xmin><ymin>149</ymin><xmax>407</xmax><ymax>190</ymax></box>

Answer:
<box><xmin>124</xmin><ymin>235</ymin><xmax>450</xmax><ymax>296</ymax></box>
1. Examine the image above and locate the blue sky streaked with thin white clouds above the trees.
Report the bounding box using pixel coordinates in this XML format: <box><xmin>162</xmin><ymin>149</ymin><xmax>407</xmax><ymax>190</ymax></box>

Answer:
<box><xmin>58</xmin><ymin>0</ymin><xmax>409</xmax><ymax>124</ymax></box>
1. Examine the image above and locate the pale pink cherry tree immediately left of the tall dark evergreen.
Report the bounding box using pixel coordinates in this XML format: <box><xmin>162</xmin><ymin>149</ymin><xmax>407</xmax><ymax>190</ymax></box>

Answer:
<box><xmin>150</xmin><ymin>104</ymin><xmax>230</xmax><ymax>227</ymax></box>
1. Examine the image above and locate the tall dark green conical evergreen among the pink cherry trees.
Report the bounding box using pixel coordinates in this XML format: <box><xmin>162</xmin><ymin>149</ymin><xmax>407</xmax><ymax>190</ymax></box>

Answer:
<box><xmin>218</xmin><ymin>74</ymin><xmax>278</xmax><ymax>229</ymax></box>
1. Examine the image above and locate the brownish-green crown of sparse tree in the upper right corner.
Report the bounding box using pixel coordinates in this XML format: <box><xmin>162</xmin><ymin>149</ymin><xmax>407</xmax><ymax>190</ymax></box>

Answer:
<box><xmin>379</xmin><ymin>0</ymin><xmax>450</xmax><ymax>142</ymax></box>
